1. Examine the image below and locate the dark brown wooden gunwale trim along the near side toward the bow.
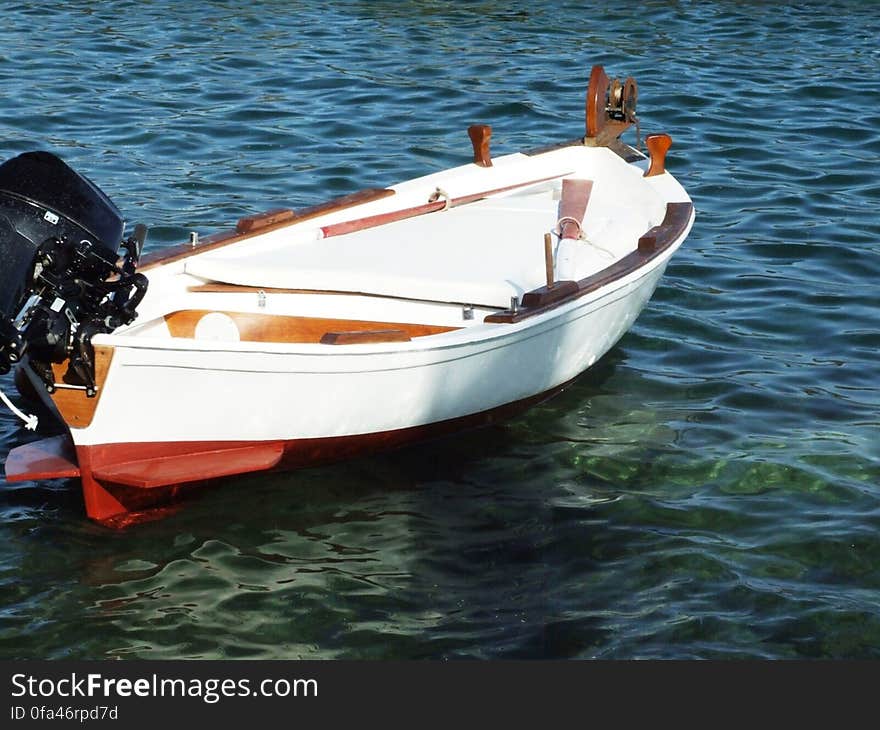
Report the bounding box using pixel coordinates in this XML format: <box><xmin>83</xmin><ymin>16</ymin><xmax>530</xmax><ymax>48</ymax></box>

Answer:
<box><xmin>483</xmin><ymin>203</ymin><xmax>694</xmax><ymax>324</ymax></box>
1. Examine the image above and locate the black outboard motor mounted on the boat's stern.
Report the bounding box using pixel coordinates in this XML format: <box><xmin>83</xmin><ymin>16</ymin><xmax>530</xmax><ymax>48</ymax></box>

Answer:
<box><xmin>0</xmin><ymin>152</ymin><xmax>147</xmax><ymax>396</ymax></box>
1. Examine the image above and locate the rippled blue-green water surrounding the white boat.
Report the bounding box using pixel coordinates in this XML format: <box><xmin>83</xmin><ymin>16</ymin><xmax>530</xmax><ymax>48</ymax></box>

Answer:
<box><xmin>0</xmin><ymin>0</ymin><xmax>880</xmax><ymax>658</ymax></box>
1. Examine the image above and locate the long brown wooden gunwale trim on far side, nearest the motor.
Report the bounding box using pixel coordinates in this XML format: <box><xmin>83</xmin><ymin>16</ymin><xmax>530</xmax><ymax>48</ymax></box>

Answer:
<box><xmin>138</xmin><ymin>188</ymin><xmax>394</xmax><ymax>271</ymax></box>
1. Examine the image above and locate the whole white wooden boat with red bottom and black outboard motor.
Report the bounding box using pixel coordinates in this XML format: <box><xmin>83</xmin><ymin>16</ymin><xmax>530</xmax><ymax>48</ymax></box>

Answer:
<box><xmin>0</xmin><ymin>66</ymin><xmax>694</xmax><ymax>524</ymax></box>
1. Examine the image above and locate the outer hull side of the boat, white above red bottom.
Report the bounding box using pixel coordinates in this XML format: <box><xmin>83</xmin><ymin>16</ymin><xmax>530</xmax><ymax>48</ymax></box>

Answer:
<box><xmin>7</xmin><ymin>250</ymin><xmax>672</xmax><ymax>524</ymax></box>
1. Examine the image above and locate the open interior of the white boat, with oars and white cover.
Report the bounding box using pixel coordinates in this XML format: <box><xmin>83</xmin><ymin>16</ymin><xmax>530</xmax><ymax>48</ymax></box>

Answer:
<box><xmin>114</xmin><ymin>142</ymin><xmax>684</xmax><ymax>345</ymax></box>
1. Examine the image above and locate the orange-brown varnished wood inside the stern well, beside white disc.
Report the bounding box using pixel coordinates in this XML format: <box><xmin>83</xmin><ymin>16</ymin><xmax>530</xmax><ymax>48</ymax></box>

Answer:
<box><xmin>165</xmin><ymin>309</ymin><xmax>459</xmax><ymax>344</ymax></box>
